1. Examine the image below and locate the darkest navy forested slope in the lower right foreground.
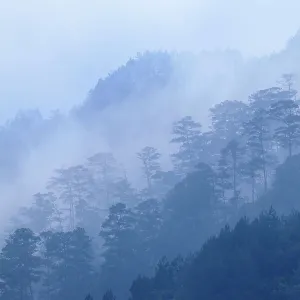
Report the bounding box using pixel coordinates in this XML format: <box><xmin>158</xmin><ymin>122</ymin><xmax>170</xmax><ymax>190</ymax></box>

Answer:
<box><xmin>130</xmin><ymin>209</ymin><xmax>300</xmax><ymax>300</ymax></box>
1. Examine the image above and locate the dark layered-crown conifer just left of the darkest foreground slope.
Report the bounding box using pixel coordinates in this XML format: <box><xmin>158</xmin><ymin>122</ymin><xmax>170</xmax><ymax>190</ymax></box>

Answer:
<box><xmin>100</xmin><ymin>203</ymin><xmax>139</xmax><ymax>295</ymax></box>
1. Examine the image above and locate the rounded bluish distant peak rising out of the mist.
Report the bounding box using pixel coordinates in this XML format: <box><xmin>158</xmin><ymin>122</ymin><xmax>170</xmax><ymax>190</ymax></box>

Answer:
<box><xmin>80</xmin><ymin>52</ymin><xmax>173</xmax><ymax>113</ymax></box>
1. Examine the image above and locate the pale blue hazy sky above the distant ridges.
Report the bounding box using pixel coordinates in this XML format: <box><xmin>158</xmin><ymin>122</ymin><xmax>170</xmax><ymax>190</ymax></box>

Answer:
<box><xmin>0</xmin><ymin>0</ymin><xmax>300</xmax><ymax>120</ymax></box>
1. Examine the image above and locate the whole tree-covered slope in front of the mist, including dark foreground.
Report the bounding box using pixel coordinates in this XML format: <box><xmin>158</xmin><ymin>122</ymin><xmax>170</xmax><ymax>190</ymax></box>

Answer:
<box><xmin>0</xmin><ymin>68</ymin><xmax>300</xmax><ymax>300</ymax></box>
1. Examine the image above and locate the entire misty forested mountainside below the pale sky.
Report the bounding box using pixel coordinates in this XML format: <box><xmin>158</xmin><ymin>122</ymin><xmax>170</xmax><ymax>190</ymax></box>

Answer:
<box><xmin>0</xmin><ymin>34</ymin><xmax>300</xmax><ymax>300</ymax></box>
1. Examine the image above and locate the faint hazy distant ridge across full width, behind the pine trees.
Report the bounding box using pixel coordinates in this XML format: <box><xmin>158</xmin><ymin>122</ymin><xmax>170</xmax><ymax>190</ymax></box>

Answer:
<box><xmin>0</xmin><ymin>32</ymin><xmax>300</xmax><ymax>190</ymax></box>
